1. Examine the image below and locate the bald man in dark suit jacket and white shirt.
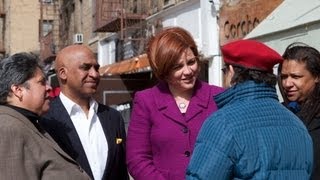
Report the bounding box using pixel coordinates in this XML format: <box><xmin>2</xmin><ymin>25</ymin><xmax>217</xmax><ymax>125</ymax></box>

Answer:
<box><xmin>41</xmin><ymin>45</ymin><xmax>129</xmax><ymax>180</ymax></box>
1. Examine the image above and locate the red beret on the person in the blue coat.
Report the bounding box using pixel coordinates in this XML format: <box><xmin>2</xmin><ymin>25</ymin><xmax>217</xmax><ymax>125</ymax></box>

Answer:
<box><xmin>221</xmin><ymin>40</ymin><xmax>283</xmax><ymax>73</ymax></box>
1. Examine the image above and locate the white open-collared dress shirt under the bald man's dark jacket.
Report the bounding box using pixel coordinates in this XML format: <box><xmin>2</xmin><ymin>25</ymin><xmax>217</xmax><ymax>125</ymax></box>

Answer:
<box><xmin>59</xmin><ymin>93</ymin><xmax>108</xmax><ymax>180</ymax></box>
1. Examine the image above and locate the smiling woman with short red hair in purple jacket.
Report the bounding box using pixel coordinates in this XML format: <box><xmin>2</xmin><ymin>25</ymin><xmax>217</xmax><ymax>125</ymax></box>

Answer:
<box><xmin>127</xmin><ymin>27</ymin><xmax>223</xmax><ymax>180</ymax></box>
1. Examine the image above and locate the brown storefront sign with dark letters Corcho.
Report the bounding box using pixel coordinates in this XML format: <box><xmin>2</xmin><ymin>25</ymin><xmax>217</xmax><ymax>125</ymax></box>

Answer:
<box><xmin>219</xmin><ymin>0</ymin><xmax>283</xmax><ymax>45</ymax></box>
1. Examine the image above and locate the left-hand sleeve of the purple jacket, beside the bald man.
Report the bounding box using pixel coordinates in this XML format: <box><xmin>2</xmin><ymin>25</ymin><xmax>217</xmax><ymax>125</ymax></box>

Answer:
<box><xmin>126</xmin><ymin>92</ymin><xmax>165</xmax><ymax>180</ymax></box>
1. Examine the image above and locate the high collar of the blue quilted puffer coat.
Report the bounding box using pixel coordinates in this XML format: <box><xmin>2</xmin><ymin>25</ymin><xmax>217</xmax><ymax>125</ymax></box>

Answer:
<box><xmin>214</xmin><ymin>81</ymin><xmax>278</xmax><ymax>108</ymax></box>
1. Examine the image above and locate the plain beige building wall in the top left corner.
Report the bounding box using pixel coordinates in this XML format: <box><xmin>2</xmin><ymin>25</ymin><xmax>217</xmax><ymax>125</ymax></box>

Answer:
<box><xmin>0</xmin><ymin>0</ymin><xmax>40</xmax><ymax>56</ymax></box>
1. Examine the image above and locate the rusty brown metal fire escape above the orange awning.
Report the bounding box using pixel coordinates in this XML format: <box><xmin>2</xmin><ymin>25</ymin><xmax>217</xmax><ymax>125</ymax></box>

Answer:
<box><xmin>95</xmin><ymin>0</ymin><xmax>149</xmax><ymax>60</ymax></box>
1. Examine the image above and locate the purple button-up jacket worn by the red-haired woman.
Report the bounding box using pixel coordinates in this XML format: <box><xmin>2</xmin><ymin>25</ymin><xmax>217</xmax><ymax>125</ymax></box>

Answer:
<box><xmin>126</xmin><ymin>80</ymin><xmax>223</xmax><ymax>180</ymax></box>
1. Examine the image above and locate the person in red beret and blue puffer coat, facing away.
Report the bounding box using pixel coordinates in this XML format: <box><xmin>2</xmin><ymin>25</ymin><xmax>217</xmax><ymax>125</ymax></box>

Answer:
<box><xmin>187</xmin><ymin>40</ymin><xmax>313</xmax><ymax>180</ymax></box>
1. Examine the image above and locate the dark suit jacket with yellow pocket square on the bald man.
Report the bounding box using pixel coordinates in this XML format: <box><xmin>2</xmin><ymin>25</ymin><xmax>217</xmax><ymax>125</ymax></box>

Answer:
<box><xmin>40</xmin><ymin>97</ymin><xmax>129</xmax><ymax>180</ymax></box>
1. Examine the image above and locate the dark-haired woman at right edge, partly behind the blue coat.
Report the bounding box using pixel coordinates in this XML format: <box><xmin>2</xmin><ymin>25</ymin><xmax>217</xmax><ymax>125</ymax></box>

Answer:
<box><xmin>279</xmin><ymin>43</ymin><xmax>320</xmax><ymax>179</ymax></box>
